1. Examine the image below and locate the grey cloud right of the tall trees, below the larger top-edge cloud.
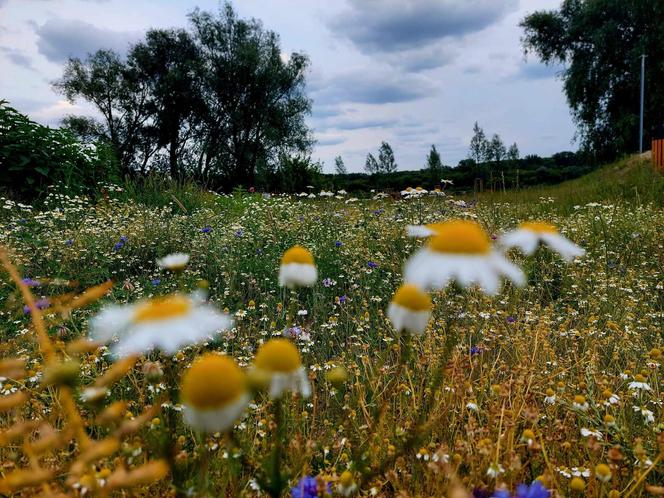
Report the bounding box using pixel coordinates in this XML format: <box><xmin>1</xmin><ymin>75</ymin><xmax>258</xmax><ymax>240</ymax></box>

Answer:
<box><xmin>312</xmin><ymin>72</ymin><xmax>435</xmax><ymax>104</ymax></box>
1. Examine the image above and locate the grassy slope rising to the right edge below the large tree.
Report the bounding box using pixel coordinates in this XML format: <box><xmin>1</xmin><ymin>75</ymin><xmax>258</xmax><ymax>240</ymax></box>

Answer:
<box><xmin>479</xmin><ymin>156</ymin><xmax>664</xmax><ymax>212</ymax></box>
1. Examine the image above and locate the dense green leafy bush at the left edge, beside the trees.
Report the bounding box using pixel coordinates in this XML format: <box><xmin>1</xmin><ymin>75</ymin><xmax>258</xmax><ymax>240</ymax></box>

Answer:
<box><xmin>0</xmin><ymin>101</ymin><xmax>116</xmax><ymax>199</ymax></box>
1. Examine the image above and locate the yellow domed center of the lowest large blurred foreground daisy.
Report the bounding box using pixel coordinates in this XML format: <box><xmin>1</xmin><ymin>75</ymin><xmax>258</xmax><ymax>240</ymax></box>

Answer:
<box><xmin>181</xmin><ymin>353</ymin><xmax>247</xmax><ymax>410</ymax></box>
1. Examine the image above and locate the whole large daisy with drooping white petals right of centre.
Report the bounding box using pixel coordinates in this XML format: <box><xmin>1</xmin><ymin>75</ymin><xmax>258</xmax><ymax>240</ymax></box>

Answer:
<box><xmin>404</xmin><ymin>220</ymin><xmax>526</xmax><ymax>294</ymax></box>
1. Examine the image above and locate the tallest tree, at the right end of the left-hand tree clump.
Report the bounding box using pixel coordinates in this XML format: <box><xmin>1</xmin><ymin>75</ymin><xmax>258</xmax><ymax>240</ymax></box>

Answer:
<box><xmin>189</xmin><ymin>3</ymin><xmax>312</xmax><ymax>185</ymax></box>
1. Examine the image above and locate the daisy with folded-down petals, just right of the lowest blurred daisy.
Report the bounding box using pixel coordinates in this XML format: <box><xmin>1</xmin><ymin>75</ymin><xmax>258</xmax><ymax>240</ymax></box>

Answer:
<box><xmin>254</xmin><ymin>339</ymin><xmax>311</xmax><ymax>398</ymax></box>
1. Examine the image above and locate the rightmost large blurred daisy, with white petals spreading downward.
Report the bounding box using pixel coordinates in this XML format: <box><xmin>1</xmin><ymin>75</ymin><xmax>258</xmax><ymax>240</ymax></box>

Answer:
<box><xmin>499</xmin><ymin>221</ymin><xmax>585</xmax><ymax>261</ymax></box>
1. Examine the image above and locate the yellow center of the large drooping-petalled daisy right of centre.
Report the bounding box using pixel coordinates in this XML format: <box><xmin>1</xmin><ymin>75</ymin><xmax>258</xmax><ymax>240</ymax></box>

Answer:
<box><xmin>429</xmin><ymin>220</ymin><xmax>491</xmax><ymax>254</ymax></box>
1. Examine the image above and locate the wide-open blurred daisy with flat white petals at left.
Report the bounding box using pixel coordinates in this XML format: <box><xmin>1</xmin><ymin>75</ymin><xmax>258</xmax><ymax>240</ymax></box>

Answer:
<box><xmin>90</xmin><ymin>292</ymin><xmax>233</xmax><ymax>356</ymax></box>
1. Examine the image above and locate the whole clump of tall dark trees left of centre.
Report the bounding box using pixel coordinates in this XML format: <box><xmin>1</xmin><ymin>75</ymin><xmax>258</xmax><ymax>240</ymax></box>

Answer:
<box><xmin>54</xmin><ymin>3</ymin><xmax>313</xmax><ymax>188</ymax></box>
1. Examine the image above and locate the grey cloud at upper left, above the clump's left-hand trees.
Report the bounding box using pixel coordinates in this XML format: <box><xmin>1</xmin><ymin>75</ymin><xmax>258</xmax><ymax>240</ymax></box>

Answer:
<box><xmin>35</xmin><ymin>19</ymin><xmax>141</xmax><ymax>62</ymax></box>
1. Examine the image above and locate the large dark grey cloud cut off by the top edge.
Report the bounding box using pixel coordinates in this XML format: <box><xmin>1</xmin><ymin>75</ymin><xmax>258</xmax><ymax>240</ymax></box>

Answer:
<box><xmin>330</xmin><ymin>0</ymin><xmax>518</xmax><ymax>53</ymax></box>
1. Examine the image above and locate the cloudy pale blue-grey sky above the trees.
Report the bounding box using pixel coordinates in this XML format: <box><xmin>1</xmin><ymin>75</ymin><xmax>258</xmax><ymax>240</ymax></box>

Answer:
<box><xmin>0</xmin><ymin>0</ymin><xmax>576</xmax><ymax>172</ymax></box>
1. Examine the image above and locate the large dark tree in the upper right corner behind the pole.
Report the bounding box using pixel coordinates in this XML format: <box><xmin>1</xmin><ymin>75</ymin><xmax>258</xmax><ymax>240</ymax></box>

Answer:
<box><xmin>521</xmin><ymin>0</ymin><xmax>664</xmax><ymax>159</ymax></box>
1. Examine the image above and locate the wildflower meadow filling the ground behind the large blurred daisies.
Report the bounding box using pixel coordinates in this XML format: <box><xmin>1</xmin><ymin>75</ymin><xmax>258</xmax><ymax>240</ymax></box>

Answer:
<box><xmin>0</xmin><ymin>160</ymin><xmax>664</xmax><ymax>498</ymax></box>
